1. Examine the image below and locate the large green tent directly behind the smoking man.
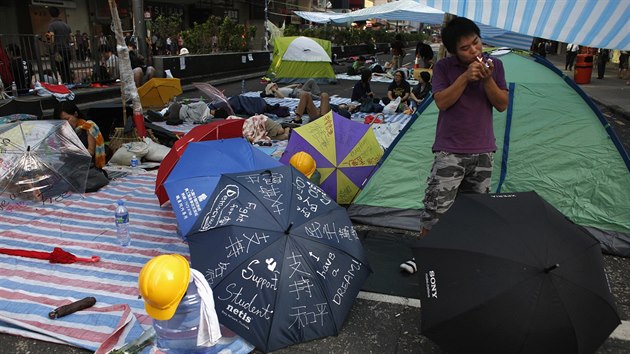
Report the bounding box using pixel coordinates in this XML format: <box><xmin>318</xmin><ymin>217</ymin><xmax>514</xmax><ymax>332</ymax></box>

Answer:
<box><xmin>348</xmin><ymin>51</ymin><xmax>630</xmax><ymax>256</ymax></box>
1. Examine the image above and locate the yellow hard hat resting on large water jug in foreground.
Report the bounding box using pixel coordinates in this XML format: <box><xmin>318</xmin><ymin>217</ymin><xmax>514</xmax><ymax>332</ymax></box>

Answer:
<box><xmin>138</xmin><ymin>254</ymin><xmax>190</xmax><ymax>321</ymax></box>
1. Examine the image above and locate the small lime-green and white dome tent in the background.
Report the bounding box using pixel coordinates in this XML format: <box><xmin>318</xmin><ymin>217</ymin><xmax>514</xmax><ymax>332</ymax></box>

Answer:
<box><xmin>268</xmin><ymin>36</ymin><xmax>337</xmax><ymax>84</ymax></box>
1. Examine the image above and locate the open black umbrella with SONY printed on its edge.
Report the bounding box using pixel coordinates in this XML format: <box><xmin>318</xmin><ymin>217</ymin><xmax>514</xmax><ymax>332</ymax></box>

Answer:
<box><xmin>414</xmin><ymin>192</ymin><xmax>620</xmax><ymax>354</ymax></box>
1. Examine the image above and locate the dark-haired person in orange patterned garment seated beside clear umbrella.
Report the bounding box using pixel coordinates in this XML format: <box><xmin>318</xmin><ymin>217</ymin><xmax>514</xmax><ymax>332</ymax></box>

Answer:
<box><xmin>53</xmin><ymin>101</ymin><xmax>106</xmax><ymax>168</ymax></box>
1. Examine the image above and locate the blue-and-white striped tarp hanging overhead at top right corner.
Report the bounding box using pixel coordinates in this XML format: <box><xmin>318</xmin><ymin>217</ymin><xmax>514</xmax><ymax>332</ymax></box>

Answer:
<box><xmin>420</xmin><ymin>0</ymin><xmax>630</xmax><ymax>50</ymax></box>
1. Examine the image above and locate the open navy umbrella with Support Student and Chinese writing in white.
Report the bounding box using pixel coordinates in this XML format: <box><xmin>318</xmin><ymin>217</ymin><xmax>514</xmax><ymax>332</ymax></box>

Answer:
<box><xmin>187</xmin><ymin>166</ymin><xmax>371</xmax><ymax>352</ymax></box>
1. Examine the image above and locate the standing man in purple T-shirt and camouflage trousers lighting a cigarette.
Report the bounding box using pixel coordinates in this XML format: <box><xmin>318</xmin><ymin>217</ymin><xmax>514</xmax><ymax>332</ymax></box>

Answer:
<box><xmin>421</xmin><ymin>17</ymin><xmax>508</xmax><ymax>236</ymax></box>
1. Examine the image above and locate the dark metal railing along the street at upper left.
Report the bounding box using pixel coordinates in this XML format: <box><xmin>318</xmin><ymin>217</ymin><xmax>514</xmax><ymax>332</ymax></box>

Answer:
<box><xmin>0</xmin><ymin>34</ymin><xmax>126</xmax><ymax>92</ymax></box>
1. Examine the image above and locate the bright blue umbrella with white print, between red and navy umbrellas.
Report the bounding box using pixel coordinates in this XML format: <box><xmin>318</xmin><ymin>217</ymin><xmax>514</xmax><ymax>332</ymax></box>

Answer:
<box><xmin>164</xmin><ymin>138</ymin><xmax>282</xmax><ymax>235</ymax></box>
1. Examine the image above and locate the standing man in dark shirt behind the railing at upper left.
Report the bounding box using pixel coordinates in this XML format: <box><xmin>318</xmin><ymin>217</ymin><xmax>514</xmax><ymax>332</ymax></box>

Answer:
<box><xmin>48</xmin><ymin>6</ymin><xmax>72</xmax><ymax>84</ymax></box>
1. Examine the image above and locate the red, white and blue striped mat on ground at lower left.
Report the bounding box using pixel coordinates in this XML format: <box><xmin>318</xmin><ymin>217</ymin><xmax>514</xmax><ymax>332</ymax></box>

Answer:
<box><xmin>0</xmin><ymin>172</ymin><xmax>251</xmax><ymax>353</ymax></box>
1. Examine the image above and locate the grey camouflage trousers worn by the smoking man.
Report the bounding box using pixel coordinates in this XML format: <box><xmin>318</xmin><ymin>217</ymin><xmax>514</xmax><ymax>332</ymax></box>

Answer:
<box><xmin>421</xmin><ymin>151</ymin><xmax>494</xmax><ymax>230</ymax></box>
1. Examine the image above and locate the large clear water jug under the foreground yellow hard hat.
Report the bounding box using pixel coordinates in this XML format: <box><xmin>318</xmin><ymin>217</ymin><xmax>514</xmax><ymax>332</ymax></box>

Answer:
<box><xmin>153</xmin><ymin>282</ymin><xmax>210</xmax><ymax>354</ymax></box>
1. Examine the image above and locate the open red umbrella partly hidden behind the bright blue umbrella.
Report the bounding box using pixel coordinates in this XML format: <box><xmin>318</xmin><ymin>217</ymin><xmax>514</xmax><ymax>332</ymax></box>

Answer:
<box><xmin>155</xmin><ymin>119</ymin><xmax>245</xmax><ymax>205</ymax></box>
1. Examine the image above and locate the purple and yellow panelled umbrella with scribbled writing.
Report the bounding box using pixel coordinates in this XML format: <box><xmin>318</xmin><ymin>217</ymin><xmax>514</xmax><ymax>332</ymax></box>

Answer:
<box><xmin>280</xmin><ymin>111</ymin><xmax>383</xmax><ymax>204</ymax></box>
